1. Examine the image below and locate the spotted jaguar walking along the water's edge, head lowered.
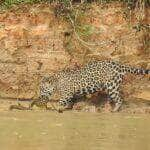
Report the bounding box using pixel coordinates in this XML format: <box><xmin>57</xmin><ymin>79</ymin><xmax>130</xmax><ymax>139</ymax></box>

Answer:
<box><xmin>30</xmin><ymin>60</ymin><xmax>150</xmax><ymax>112</ymax></box>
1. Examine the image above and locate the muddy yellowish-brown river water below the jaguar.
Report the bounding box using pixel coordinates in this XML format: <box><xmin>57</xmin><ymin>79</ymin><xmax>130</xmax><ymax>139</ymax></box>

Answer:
<box><xmin>0</xmin><ymin>111</ymin><xmax>150</xmax><ymax>150</ymax></box>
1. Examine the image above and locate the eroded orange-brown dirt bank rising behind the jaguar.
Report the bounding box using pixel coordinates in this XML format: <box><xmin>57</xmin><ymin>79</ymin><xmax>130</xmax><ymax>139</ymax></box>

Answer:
<box><xmin>0</xmin><ymin>3</ymin><xmax>150</xmax><ymax>112</ymax></box>
